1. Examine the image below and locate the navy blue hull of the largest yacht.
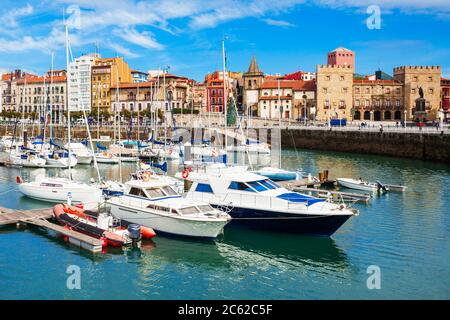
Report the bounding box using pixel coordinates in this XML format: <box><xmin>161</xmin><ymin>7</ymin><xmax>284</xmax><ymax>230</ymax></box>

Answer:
<box><xmin>213</xmin><ymin>205</ymin><xmax>352</xmax><ymax>237</ymax></box>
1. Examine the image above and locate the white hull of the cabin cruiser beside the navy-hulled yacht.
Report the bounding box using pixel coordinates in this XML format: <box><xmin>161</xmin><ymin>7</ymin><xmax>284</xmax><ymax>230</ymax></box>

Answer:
<box><xmin>108</xmin><ymin>198</ymin><xmax>229</xmax><ymax>238</ymax></box>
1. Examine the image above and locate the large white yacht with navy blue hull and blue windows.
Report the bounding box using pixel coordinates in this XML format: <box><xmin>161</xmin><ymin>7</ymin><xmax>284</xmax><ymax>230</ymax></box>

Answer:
<box><xmin>182</xmin><ymin>165</ymin><xmax>358</xmax><ymax>236</ymax></box>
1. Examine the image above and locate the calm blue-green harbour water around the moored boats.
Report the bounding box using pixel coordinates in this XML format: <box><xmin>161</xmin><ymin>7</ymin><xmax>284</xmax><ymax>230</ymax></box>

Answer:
<box><xmin>0</xmin><ymin>150</ymin><xmax>450</xmax><ymax>299</ymax></box>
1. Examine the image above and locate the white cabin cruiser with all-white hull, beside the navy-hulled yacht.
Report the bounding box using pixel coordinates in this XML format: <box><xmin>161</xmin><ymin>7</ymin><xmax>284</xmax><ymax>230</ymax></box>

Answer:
<box><xmin>106</xmin><ymin>174</ymin><xmax>231</xmax><ymax>238</ymax></box>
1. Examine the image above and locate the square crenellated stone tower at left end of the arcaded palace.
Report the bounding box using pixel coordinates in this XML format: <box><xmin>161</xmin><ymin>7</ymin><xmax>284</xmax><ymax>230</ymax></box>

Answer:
<box><xmin>316</xmin><ymin>65</ymin><xmax>354</xmax><ymax>121</ymax></box>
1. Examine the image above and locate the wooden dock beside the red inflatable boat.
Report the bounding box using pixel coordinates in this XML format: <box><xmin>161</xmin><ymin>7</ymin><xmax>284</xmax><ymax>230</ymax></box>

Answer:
<box><xmin>0</xmin><ymin>208</ymin><xmax>103</xmax><ymax>253</ymax></box>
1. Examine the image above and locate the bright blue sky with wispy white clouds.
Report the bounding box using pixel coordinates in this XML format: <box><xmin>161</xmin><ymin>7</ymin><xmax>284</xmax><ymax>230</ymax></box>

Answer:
<box><xmin>0</xmin><ymin>0</ymin><xmax>450</xmax><ymax>80</ymax></box>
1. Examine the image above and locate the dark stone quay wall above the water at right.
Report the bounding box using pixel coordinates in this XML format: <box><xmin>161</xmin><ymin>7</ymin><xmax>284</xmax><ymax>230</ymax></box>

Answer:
<box><xmin>281</xmin><ymin>129</ymin><xmax>450</xmax><ymax>163</ymax></box>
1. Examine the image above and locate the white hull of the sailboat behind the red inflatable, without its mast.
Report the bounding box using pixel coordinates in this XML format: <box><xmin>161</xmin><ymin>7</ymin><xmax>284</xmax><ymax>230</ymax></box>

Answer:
<box><xmin>17</xmin><ymin>175</ymin><xmax>103</xmax><ymax>206</ymax></box>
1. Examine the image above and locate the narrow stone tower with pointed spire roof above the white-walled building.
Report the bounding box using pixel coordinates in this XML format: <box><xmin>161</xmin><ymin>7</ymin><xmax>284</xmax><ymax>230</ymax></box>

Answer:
<box><xmin>242</xmin><ymin>56</ymin><xmax>264</xmax><ymax>112</ymax></box>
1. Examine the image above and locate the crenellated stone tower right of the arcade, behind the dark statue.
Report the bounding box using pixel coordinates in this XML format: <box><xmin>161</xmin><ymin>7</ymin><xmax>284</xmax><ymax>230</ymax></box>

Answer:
<box><xmin>394</xmin><ymin>66</ymin><xmax>441</xmax><ymax>120</ymax></box>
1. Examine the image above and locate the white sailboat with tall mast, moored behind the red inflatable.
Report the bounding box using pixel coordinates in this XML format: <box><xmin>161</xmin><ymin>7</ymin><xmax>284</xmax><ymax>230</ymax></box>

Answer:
<box><xmin>17</xmin><ymin>23</ymin><xmax>103</xmax><ymax>208</ymax></box>
